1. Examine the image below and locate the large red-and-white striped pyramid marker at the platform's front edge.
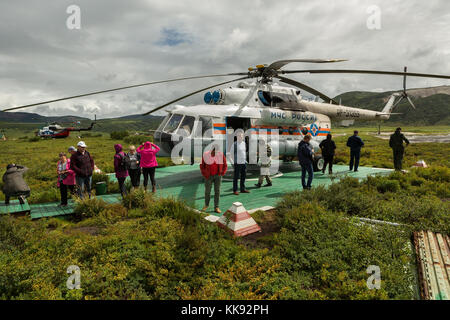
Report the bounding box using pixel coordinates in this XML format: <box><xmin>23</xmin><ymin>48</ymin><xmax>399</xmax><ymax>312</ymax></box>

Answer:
<box><xmin>216</xmin><ymin>202</ymin><xmax>261</xmax><ymax>237</ymax></box>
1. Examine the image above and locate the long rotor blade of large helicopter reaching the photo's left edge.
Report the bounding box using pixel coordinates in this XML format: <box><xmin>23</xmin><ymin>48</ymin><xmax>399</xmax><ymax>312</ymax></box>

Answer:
<box><xmin>2</xmin><ymin>72</ymin><xmax>247</xmax><ymax>111</ymax></box>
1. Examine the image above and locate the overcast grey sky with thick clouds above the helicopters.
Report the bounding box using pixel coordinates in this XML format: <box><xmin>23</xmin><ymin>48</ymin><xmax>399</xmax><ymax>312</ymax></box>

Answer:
<box><xmin>0</xmin><ymin>0</ymin><xmax>450</xmax><ymax>118</ymax></box>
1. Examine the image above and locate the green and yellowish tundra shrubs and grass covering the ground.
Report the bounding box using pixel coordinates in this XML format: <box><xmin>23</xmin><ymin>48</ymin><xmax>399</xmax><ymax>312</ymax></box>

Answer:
<box><xmin>0</xmin><ymin>125</ymin><xmax>450</xmax><ymax>299</ymax></box>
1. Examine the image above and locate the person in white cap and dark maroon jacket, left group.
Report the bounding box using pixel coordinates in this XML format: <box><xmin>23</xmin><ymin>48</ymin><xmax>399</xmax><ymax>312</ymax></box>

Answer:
<box><xmin>70</xmin><ymin>141</ymin><xmax>94</xmax><ymax>199</ymax></box>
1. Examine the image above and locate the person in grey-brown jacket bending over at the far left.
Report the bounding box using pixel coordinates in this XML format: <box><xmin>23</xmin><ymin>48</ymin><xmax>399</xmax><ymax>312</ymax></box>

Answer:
<box><xmin>2</xmin><ymin>163</ymin><xmax>30</xmax><ymax>205</ymax></box>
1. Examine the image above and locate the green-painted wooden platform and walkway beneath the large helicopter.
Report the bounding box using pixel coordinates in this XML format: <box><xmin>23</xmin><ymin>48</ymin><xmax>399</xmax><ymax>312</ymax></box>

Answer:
<box><xmin>0</xmin><ymin>164</ymin><xmax>392</xmax><ymax>219</ymax></box>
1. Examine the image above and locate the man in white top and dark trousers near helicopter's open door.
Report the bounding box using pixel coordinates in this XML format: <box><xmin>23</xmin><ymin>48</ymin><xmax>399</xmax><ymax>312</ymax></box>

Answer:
<box><xmin>228</xmin><ymin>130</ymin><xmax>250</xmax><ymax>195</ymax></box>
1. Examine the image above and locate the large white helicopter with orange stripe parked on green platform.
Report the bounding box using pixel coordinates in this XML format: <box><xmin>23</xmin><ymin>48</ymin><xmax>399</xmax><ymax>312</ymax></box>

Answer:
<box><xmin>3</xmin><ymin>59</ymin><xmax>450</xmax><ymax>171</ymax></box>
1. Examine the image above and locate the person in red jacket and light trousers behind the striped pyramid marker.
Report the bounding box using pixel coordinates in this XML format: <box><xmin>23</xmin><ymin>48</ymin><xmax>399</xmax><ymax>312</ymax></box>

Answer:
<box><xmin>200</xmin><ymin>144</ymin><xmax>227</xmax><ymax>213</ymax></box>
